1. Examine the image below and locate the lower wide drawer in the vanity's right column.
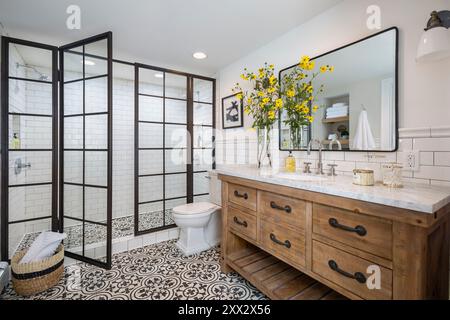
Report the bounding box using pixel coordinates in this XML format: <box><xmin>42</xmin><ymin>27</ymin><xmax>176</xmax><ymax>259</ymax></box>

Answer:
<box><xmin>312</xmin><ymin>241</ymin><xmax>392</xmax><ymax>300</ymax></box>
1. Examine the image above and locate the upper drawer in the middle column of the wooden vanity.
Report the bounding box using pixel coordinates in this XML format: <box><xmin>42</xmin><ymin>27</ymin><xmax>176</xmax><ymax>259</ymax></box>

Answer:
<box><xmin>258</xmin><ymin>191</ymin><xmax>306</xmax><ymax>229</ymax></box>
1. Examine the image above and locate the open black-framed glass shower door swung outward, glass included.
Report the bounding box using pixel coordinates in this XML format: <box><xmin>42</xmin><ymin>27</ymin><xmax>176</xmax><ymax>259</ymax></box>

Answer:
<box><xmin>60</xmin><ymin>32</ymin><xmax>112</xmax><ymax>269</ymax></box>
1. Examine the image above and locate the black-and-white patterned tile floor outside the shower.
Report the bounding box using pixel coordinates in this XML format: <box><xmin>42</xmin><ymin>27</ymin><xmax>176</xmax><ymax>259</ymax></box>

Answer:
<box><xmin>0</xmin><ymin>240</ymin><xmax>266</xmax><ymax>300</ymax></box>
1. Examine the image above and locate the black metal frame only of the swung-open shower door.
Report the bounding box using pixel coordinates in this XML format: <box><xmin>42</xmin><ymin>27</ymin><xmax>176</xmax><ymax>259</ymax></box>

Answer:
<box><xmin>59</xmin><ymin>32</ymin><xmax>113</xmax><ymax>269</ymax></box>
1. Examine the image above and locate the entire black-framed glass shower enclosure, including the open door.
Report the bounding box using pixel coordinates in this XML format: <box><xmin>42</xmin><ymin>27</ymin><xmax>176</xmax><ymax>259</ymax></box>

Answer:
<box><xmin>1</xmin><ymin>32</ymin><xmax>215</xmax><ymax>268</ymax></box>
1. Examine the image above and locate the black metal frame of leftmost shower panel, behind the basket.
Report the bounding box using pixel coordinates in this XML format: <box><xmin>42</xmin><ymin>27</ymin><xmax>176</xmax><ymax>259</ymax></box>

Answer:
<box><xmin>0</xmin><ymin>36</ymin><xmax>58</xmax><ymax>261</ymax></box>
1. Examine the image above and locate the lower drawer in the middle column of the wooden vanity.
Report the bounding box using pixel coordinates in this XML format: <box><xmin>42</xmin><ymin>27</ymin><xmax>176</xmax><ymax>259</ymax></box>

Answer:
<box><xmin>260</xmin><ymin>219</ymin><xmax>305</xmax><ymax>267</ymax></box>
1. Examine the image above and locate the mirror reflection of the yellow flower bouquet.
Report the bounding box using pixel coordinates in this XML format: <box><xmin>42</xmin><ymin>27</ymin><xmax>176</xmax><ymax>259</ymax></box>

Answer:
<box><xmin>280</xmin><ymin>56</ymin><xmax>334</xmax><ymax>149</ymax></box>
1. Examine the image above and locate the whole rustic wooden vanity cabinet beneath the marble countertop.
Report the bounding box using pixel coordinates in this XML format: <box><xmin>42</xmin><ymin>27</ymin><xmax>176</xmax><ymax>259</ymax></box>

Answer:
<box><xmin>219</xmin><ymin>175</ymin><xmax>450</xmax><ymax>300</ymax></box>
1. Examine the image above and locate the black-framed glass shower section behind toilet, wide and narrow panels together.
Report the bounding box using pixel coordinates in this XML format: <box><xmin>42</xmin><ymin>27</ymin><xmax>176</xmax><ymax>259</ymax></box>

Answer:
<box><xmin>134</xmin><ymin>64</ymin><xmax>215</xmax><ymax>235</ymax></box>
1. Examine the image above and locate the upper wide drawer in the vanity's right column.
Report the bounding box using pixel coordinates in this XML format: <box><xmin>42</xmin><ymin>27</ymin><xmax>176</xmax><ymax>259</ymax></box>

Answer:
<box><xmin>313</xmin><ymin>204</ymin><xmax>392</xmax><ymax>259</ymax></box>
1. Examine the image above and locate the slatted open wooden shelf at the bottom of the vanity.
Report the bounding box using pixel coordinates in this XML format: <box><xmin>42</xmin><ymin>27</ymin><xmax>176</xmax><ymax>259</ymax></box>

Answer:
<box><xmin>228</xmin><ymin>244</ymin><xmax>346</xmax><ymax>300</ymax></box>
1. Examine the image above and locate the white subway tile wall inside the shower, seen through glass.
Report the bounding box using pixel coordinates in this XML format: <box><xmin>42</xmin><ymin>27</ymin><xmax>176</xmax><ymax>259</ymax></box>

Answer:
<box><xmin>4</xmin><ymin>49</ymin><xmax>212</xmax><ymax>254</ymax></box>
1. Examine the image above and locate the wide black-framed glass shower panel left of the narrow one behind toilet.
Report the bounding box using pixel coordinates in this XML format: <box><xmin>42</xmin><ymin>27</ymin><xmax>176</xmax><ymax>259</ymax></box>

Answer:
<box><xmin>135</xmin><ymin>64</ymin><xmax>188</xmax><ymax>235</ymax></box>
